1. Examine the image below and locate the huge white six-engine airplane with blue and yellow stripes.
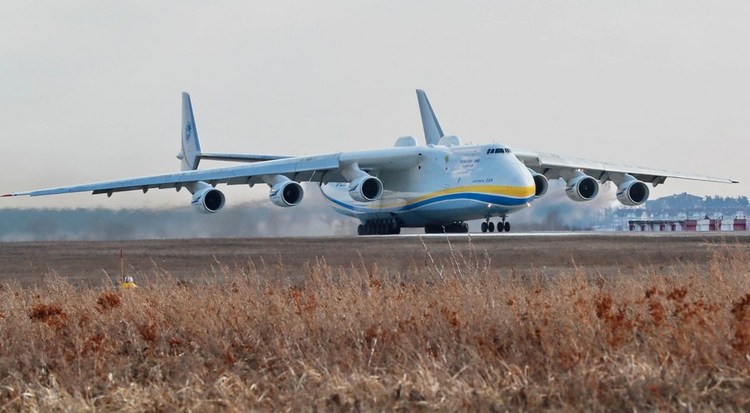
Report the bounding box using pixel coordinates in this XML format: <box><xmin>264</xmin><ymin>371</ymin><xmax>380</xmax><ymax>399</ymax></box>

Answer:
<box><xmin>2</xmin><ymin>89</ymin><xmax>738</xmax><ymax>235</ymax></box>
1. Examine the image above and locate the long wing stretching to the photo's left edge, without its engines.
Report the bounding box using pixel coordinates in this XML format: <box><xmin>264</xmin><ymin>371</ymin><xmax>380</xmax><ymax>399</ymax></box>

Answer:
<box><xmin>2</xmin><ymin>148</ymin><xmax>420</xmax><ymax>197</ymax></box>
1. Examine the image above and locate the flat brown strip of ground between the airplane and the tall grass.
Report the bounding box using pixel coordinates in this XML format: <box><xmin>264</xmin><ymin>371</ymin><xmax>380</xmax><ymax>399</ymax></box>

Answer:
<box><xmin>0</xmin><ymin>232</ymin><xmax>750</xmax><ymax>285</ymax></box>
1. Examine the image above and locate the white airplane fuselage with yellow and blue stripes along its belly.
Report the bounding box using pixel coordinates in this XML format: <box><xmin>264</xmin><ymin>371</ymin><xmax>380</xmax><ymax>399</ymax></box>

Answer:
<box><xmin>321</xmin><ymin>145</ymin><xmax>535</xmax><ymax>227</ymax></box>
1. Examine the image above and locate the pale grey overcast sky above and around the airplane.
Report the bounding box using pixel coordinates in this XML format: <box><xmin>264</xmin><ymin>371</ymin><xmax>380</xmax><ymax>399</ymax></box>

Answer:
<box><xmin>0</xmin><ymin>0</ymin><xmax>750</xmax><ymax>208</ymax></box>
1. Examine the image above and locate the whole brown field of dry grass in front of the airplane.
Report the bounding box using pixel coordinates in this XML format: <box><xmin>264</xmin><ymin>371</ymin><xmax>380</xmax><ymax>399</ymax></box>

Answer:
<box><xmin>0</xmin><ymin>236</ymin><xmax>750</xmax><ymax>411</ymax></box>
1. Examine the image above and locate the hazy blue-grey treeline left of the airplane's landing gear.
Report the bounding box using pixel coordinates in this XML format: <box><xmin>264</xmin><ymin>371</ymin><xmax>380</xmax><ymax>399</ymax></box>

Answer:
<box><xmin>0</xmin><ymin>203</ymin><xmax>356</xmax><ymax>241</ymax></box>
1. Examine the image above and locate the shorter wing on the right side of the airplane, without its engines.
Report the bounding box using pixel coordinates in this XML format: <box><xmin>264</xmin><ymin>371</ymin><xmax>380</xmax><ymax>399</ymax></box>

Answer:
<box><xmin>515</xmin><ymin>151</ymin><xmax>739</xmax><ymax>186</ymax></box>
